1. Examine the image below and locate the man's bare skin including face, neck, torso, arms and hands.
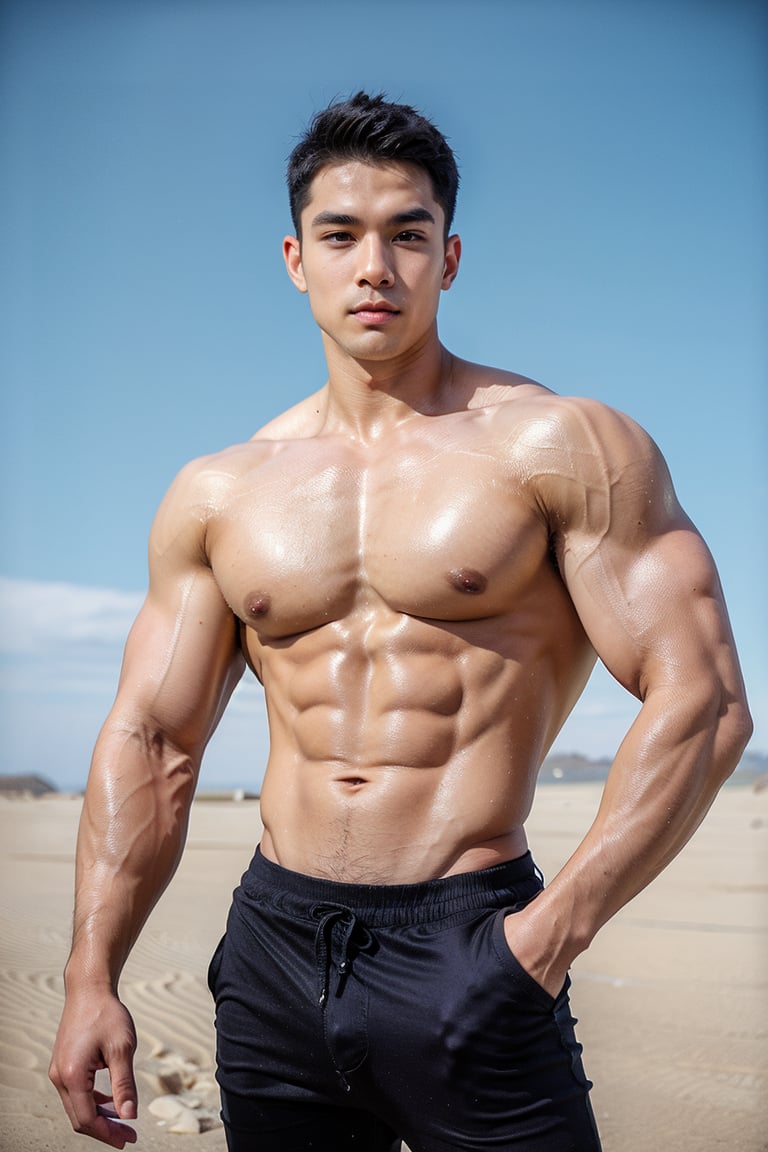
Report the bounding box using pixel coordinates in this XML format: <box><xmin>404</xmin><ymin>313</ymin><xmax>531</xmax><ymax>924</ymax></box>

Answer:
<box><xmin>51</xmin><ymin>162</ymin><xmax>751</xmax><ymax>1147</ymax></box>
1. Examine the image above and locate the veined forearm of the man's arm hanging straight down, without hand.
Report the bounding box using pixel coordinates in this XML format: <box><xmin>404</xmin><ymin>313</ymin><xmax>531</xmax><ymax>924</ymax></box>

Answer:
<box><xmin>66</xmin><ymin>719</ymin><xmax>197</xmax><ymax>990</ymax></box>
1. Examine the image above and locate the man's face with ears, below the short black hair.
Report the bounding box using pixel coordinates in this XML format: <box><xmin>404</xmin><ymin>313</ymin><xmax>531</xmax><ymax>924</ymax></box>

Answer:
<box><xmin>283</xmin><ymin>160</ymin><xmax>461</xmax><ymax>361</ymax></box>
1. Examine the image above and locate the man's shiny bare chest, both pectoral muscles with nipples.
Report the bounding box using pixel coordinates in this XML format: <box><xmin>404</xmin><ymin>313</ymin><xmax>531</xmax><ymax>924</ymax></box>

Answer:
<box><xmin>210</xmin><ymin>440</ymin><xmax>547</xmax><ymax>636</ymax></box>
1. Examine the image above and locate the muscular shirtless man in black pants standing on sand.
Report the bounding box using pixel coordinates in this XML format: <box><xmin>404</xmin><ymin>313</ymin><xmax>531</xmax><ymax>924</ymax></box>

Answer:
<box><xmin>51</xmin><ymin>93</ymin><xmax>750</xmax><ymax>1152</ymax></box>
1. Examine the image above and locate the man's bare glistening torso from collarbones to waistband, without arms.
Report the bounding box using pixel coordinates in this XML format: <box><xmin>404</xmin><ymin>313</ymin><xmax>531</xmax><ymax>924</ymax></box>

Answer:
<box><xmin>198</xmin><ymin>368</ymin><xmax>594</xmax><ymax>884</ymax></box>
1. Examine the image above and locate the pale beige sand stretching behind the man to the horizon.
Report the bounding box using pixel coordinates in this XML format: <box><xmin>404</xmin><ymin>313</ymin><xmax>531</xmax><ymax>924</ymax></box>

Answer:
<box><xmin>0</xmin><ymin>785</ymin><xmax>768</xmax><ymax>1152</ymax></box>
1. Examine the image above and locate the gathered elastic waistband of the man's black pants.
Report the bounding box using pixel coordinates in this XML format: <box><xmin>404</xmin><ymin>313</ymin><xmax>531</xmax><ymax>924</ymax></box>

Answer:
<box><xmin>242</xmin><ymin>848</ymin><xmax>542</xmax><ymax>925</ymax></box>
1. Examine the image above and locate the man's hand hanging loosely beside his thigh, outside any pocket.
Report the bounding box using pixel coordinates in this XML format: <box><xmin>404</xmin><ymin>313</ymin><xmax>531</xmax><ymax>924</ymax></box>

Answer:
<box><xmin>48</xmin><ymin>992</ymin><xmax>138</xmax><ymax>1149</ymax></box>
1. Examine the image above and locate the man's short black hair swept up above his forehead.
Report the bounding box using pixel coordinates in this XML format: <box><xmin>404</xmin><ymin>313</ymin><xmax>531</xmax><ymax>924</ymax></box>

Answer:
<box><xmin>288</xmin><ymin>92</ymin><xmax>458</xmax><ymax>238</ymax></box>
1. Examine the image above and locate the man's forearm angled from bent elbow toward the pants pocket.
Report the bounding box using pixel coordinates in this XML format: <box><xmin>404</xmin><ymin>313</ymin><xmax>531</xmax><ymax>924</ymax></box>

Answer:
<box><xmin>522</xmin><ymin>685</ymin><xmax>751</xmax><ymax>971</ymax></box>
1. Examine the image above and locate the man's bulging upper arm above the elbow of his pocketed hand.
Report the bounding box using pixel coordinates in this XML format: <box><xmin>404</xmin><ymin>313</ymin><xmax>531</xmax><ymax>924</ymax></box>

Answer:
<box><xmin>539</xmin><ymin>401</ymin><xmax>738</xmax><ymax>699</ymax></box>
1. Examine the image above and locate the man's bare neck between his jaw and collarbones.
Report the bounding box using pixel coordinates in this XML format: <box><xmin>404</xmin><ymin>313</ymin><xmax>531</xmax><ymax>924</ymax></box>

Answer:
<box><xmin>326</xmin><ymin>336</ymin><xmax>455</xmax><ymax>440</ymax></box>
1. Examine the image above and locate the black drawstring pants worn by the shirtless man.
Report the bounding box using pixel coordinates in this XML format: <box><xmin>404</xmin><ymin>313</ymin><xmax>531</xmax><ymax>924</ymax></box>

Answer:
<box><xmin>208</xmin><ymin>851</ymin><xmax>600</xmax><ymax>1152</ymax></box>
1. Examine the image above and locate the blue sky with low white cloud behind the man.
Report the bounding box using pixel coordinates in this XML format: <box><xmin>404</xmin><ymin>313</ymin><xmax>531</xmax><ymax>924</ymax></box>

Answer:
<box><xmin>0</xmin><ymin>0</ymin><xmax>768</xmax><ymax>787</ymax></box>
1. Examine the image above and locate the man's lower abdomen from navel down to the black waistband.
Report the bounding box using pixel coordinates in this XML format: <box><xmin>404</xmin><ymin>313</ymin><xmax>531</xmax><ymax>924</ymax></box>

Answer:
<box><xmin>261</xmin><ymin>760</ymin><xmax>533</xmax><ymax>886</ymax></box>
